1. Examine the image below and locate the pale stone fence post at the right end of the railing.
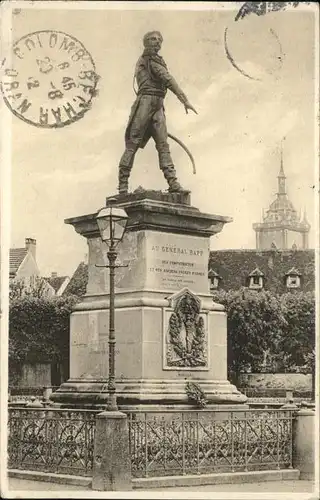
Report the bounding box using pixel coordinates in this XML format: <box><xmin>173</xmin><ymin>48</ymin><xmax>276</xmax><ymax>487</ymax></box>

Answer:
<box><xmin>293</xmin><ymin>408</ymin><xmax>315</xmax><ymax>480</ymax></box>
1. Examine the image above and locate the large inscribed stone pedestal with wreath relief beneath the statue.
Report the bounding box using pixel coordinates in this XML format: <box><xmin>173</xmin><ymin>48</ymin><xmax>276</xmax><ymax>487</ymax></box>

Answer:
<box><xmin>51</xmin><ymin>191</ymin><xmax>246</xmax><ymax>406</ymax></box>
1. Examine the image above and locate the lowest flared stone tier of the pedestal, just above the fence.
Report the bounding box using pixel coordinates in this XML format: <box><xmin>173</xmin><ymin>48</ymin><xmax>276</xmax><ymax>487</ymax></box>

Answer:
<box><xmin>51</xmin><ymin>379</ymin><xmax>247</xmax><ymax>407</ymax></box>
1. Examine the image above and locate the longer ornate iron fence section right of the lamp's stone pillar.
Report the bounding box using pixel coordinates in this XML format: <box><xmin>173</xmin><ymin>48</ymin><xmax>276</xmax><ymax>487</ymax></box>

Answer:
<box><xmin>129</xmin><ymin>410</ymin><xmax>293</xmax><ymax>477</ymax></box>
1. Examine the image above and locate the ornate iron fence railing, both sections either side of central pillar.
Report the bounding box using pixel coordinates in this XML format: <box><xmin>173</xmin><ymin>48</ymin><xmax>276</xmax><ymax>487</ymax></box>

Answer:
<box><xmin>8</xmin><ymin>407</ymin><xmax>294</xmax><ymax>477</ymax></box>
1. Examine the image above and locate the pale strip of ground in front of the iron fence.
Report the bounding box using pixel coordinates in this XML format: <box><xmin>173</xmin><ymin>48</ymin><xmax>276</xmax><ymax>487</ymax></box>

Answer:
<box><xmin>8</xmin><ymin>478</ymin><xmax>317</xmax><ymax>492</ymax></box>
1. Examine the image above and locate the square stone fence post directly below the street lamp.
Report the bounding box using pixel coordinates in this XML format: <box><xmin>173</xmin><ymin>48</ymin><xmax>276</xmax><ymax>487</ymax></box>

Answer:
<box><xmin>92</xmin><ymin>411</ymin><xmax>132</xmax><ymax>491</ymax></box>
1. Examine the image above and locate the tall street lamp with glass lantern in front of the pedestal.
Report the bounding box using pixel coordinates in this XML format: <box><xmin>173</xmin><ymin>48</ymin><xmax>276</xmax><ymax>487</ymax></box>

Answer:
<box><xmin>96</xmin><ymin>200</ymin><xmax>128</xmax><ymax>411</ymax></box>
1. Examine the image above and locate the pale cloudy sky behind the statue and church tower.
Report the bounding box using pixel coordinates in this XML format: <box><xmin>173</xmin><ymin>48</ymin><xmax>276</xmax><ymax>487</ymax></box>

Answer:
<box><xmin>2</xmin><ymin>2</ymin><xmax>317</xmax><ymax>276</ymax></box>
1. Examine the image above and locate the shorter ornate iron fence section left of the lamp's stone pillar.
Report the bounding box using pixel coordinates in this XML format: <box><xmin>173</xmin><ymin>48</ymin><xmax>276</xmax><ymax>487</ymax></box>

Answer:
<box><xmin>8</xmin><ymin>408</ymin><xmax>97</xmax><ymax>476</ymax></box>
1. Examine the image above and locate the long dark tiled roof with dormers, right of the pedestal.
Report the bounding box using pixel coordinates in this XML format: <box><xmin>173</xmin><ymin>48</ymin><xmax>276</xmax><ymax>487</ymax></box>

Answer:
<box><xmin>209</xmin><ymin>249</ymin><xmax>315</xmax><ymax>294</ymax></box>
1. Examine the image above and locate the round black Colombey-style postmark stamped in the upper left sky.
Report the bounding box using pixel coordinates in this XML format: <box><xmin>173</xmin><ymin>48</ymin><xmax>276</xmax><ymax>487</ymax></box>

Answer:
<box><xmin>0</xmin><ymin>30</ymin><xmax>99</xmax><ymax>128</ymax></box>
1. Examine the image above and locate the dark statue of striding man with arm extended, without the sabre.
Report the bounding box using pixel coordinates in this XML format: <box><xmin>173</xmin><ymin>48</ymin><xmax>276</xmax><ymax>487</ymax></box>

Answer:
<box><xmin>119</xmin><ymin>31</ymin><xmax>196</xmax><ymax>194</ymax></box>
